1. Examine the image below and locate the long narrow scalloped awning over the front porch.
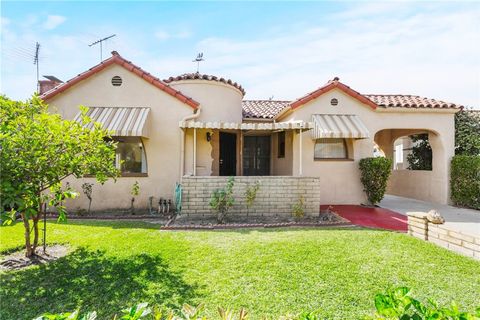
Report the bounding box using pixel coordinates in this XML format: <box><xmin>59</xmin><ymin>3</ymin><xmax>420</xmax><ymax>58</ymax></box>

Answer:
<box><xmin>179</xmin><ymin>121</ymin><xmax>313</xmax><ymax>130</ymax></box>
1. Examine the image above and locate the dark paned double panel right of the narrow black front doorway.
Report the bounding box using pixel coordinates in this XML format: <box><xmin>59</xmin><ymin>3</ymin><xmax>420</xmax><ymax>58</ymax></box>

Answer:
<box><xmin>243</xmin><ymin>136</ymin><xmax>270</xmax><ymax>176</ymax></box>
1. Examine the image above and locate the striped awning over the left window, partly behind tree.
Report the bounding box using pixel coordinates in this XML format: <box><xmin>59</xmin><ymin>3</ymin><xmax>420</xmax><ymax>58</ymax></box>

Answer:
<box><xmin>74</xmin><ymin>107</ymin><xmax>150</xmax><ymax>138</ymax></box>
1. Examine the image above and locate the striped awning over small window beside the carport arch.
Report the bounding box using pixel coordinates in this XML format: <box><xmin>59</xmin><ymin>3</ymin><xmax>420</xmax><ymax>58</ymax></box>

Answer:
<box><xmin>311</xmin><ymin>114</ymin><xmax>370</xmax><ymax>139</ymax></box>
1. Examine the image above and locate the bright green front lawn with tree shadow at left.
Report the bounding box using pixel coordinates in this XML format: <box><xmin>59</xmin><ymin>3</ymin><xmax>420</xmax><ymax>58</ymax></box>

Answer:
<box><xmin>0</xmin><ymin>221</ymin><xmax>480</xmax><ymax>320</ymax></box>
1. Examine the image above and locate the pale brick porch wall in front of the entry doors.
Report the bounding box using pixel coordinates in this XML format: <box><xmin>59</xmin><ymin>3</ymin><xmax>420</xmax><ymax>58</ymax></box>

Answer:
<box><xmin>182</xmin><ymin>176</ymin><xmax>320</xmax><ymax>216</ymax></box>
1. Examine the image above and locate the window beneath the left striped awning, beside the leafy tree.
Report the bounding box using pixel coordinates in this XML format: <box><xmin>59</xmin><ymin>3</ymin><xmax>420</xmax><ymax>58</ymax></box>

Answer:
<box><xmin>114</xmin><ymin>137</ymin><xmax>147</xmax><ymax>175</ymax></box>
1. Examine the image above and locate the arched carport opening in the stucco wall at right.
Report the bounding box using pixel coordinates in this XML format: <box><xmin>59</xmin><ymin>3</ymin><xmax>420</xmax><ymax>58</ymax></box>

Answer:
<box><xmin>374</xmin><ymin>128</ymin><xmax>449</xmax><ymax>203</ymax></box>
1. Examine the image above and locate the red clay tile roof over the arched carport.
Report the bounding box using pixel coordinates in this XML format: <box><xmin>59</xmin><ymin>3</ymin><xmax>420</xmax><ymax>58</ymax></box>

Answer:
<box><xmin>364</xmin><ymin>94</ymin><xmax>463</xmax><ymax>109</ymax></box>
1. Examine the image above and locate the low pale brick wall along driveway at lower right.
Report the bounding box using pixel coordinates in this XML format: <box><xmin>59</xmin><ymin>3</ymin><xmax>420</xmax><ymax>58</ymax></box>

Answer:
<box><xmin>407</xmin><ymin>212</ymin><xmax>480</xmax><ymax>260</ymax></box>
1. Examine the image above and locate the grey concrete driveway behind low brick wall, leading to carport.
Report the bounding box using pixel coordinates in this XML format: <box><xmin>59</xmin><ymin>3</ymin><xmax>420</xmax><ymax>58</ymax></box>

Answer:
<box><xmin>379</xmin><ymin>195</ymin><xmax>480</xmax><ymax>235</ymax></box>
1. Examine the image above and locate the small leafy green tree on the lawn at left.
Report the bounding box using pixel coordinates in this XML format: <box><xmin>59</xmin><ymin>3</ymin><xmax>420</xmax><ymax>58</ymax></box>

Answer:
<box><xmin>0</xmin><ymin>96</ymin><xmax>118</xmax><ymax>257</ymax></box>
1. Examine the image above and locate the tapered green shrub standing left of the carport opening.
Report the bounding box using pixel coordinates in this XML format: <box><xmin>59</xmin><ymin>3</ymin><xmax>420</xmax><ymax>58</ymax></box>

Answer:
<box><xmin>360</xmin><ymin>157</ymin><xmax>392</xmax><ymax>205</ymax></box>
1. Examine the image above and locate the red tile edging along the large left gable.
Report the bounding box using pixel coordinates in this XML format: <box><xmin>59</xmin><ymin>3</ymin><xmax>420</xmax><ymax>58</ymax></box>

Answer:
<box><xmin>40</xmin><ymin>51</ymin><xmax>200</xmax><ymax>109</ymax></box>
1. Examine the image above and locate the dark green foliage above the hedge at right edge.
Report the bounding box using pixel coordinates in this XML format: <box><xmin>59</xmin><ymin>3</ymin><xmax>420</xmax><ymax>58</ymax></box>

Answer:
<box><xmin>455</xmin><ymin>110</ymin><xmax>480</xmax><ymax>156</ymax></box>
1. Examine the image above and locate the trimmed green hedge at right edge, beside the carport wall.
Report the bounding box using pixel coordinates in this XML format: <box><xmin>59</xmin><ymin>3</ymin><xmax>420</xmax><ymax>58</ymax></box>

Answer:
<box><xmin>450</xmin><ymin>156</ymin><xmax>480</xmax><ymax>209</ymax></box>
